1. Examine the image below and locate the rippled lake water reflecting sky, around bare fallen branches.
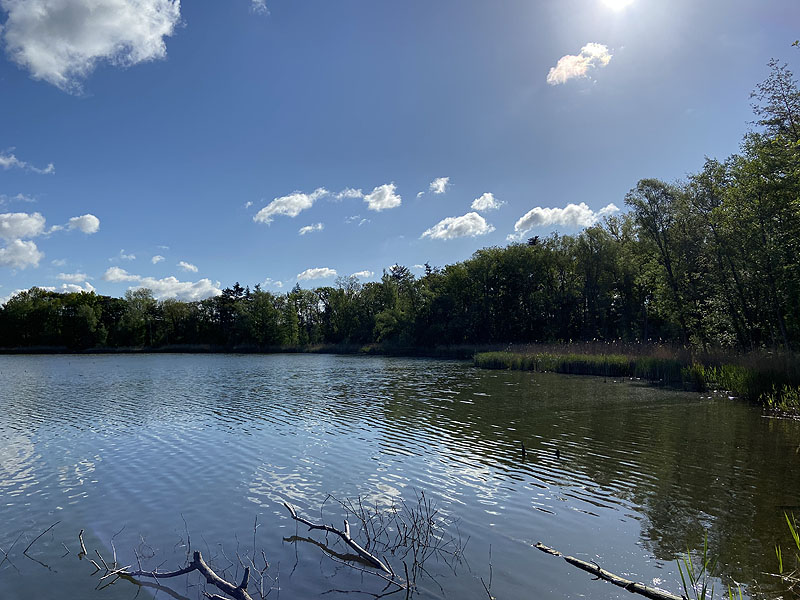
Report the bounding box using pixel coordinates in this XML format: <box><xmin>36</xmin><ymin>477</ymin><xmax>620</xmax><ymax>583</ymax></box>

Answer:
<box><xmin>0</xmin><ymin>355</ymin><xmax>800</xmax><ymax>600</ymax></box>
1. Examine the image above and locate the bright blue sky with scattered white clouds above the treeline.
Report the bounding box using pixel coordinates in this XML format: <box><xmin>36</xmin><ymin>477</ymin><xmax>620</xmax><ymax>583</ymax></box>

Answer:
<box><xmin>0</xmin><ymin>0</ymin><xmax>800</xmax><ymax>300</ymax></box>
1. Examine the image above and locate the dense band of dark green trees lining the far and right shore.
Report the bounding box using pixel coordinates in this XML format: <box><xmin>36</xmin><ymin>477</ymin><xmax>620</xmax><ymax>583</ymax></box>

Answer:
<box><xmin>0</xmin><ymin>61</ymin><xmax>800</xmax><ymax>350</ymax></box>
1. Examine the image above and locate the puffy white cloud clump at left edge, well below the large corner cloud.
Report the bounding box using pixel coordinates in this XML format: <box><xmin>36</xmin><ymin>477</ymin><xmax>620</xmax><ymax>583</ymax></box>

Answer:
<box><xmin>0</xmin><ymin>212</ymin><xmax>100</xmax><ymax>269</ymax></box>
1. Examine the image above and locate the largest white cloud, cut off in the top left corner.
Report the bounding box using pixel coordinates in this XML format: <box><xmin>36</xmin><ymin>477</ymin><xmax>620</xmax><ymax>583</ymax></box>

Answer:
<box><xmin>0</xmin><ymin>0</ymin><xmax>180</xmax><ymax>92</ymax></box>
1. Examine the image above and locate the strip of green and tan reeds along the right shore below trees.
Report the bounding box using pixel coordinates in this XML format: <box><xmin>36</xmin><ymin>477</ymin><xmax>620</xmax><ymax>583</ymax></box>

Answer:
<box><xmin>474</xmin><ymin>344</ymin><xmax>800</xmax><ymax>413</ymax></box>
